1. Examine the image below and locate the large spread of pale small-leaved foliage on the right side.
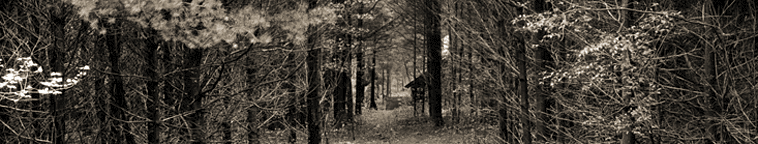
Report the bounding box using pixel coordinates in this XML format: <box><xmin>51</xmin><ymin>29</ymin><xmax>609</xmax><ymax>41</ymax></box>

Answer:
<box><xmin>513</xmin><ymin>0</ymin><xmax>681</xmax><ymax>140</ymax></box>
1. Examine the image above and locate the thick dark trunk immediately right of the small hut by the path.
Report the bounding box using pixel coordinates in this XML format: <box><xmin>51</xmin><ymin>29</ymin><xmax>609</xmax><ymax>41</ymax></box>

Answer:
<box><xmin>425</xmin><ymin>0</ymin><xmax>445</xmax><ymax>126</ymax></box>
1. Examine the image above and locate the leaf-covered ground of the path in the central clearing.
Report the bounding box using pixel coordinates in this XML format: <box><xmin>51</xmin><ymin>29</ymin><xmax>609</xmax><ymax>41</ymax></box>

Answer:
<box><xmin>327</xmin><ymin>106</ymin><xmax>499</xmax><ymax>144</ymax></box>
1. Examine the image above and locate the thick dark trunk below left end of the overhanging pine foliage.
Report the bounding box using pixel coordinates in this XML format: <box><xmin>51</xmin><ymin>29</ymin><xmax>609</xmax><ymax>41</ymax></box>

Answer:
<box><xmin>105</xmin><ymin>19</ymin><xmax>135</xmax><ymax>144</ymax></box>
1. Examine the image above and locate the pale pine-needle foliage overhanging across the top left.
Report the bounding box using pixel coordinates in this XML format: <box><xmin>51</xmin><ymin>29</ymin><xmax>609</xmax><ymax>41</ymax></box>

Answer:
<box><xmin>67</xmin><ymin>0</ymin><xmax>336</xmax><ymax>48</ymax></box>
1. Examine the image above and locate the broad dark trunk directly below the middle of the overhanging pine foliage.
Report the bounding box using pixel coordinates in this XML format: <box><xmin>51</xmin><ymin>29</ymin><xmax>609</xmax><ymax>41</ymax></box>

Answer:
<box><xmin>182</xmin><ymin>48</ymin><xmax>205</xmax><ymax>144</ymax></box>
